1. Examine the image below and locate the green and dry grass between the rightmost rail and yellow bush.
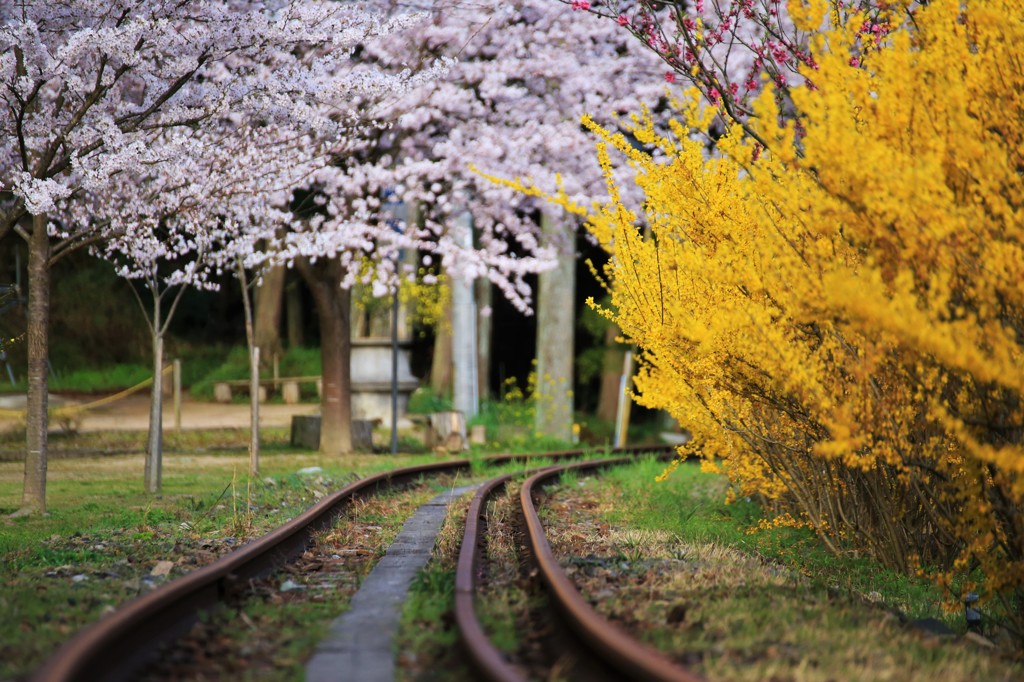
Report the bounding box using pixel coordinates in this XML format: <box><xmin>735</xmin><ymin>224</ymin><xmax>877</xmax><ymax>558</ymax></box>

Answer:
<box><xmin>543</xmin><ymin>461</ymin><xmax>1024</xmax><ymax>681</ymax></box>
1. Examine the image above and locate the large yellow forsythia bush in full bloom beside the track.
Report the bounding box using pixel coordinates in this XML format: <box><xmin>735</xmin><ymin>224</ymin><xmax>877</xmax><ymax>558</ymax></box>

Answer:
<box><xmin>569</xmin><ymin>0</ymin><xmax>1024</xmax><ymax>634</ymax></box>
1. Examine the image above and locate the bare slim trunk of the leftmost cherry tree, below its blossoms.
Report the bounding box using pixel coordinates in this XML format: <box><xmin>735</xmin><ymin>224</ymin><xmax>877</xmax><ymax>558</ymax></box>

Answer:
<box><xmin>15</xmin><ymin>215</ymin><xmax>50</xmax><ymax>515</ymax></box>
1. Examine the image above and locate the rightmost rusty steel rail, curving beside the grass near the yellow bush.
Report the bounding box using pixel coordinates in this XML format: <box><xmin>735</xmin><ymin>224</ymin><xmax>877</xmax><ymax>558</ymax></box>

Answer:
<box><xmin>519</xmin><ymin>459</ymin><xmax>703</xmax><ymax>682</ymax></box>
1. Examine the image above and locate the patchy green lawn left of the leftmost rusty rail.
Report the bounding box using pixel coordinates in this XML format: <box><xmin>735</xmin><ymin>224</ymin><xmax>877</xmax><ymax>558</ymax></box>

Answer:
<box><xmin>0</xmin><ymin>444</ymin><xmax>448</xmax><ymax>679</ymax></box>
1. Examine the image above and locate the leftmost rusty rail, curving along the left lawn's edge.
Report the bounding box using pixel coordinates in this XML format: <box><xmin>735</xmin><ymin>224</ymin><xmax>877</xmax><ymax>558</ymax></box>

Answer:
<box><xmin>32</xmin><ymin>447</ymin><xmax>667</xmax><ymax>682</ymax></box>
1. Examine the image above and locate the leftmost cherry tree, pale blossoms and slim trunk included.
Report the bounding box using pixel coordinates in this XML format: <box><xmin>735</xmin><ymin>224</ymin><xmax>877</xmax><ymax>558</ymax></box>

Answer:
<box><xmin>0</xmin><ymin>0</ymin><xmax>440</xmax><ymax>513</ymax></box>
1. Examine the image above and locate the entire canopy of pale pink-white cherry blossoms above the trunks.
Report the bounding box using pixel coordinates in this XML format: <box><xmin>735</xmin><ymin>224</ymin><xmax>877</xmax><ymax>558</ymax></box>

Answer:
<box><xmin>0</xmin><ymin>0</ymin><xmax>664</xmax><ymax>309</ymax></box>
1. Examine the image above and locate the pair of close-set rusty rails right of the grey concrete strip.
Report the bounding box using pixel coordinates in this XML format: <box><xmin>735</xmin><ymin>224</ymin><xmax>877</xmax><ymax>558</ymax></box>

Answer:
<box><xmin>455</xmin><ymin>450</ymin><xmax>703</xmax><ymax>682</ymax></box>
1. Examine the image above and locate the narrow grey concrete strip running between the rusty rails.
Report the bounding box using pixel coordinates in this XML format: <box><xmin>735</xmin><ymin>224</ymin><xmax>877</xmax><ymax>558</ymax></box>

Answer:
<box><xmin>306</xmin><ymin>485</ymin><xmax>477</xmax><ymax>682</ymax></box>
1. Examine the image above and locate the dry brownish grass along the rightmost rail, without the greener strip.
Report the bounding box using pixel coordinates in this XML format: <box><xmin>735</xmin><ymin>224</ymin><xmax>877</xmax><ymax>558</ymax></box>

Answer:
<box><xmin>542</xmin><ymin>479</ymin><xmax>1024</xmax><ymax>682</ymax></box>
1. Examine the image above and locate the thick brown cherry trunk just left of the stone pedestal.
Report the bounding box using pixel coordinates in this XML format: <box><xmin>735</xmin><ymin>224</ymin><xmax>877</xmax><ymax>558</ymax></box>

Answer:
<box><xmin>298</xmin><ymin>260</ymin><xmax>352</xmax><ymax>455</ymax></box>
